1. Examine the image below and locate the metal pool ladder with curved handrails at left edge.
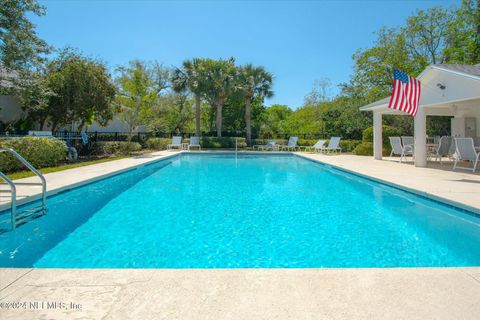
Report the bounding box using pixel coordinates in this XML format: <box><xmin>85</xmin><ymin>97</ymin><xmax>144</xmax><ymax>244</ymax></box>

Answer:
<box><xmin>0</xmin><ymin>148</ymin><xmax>47</xmax><ymax>230</ymax></box>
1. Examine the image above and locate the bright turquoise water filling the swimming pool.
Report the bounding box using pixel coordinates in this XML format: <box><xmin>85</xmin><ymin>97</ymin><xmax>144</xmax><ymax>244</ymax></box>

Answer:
<box><xmin>0</xmin><ymin>154</ymin><xmax>480</xmax><ymax>268</ymax></box>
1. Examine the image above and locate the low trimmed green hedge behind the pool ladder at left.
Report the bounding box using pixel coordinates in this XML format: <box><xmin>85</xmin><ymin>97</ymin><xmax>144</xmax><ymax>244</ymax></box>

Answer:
<box><xmin>0</xmin><ymin>137</ymin><xmax>68</xmax><ymax>172</ymax></box>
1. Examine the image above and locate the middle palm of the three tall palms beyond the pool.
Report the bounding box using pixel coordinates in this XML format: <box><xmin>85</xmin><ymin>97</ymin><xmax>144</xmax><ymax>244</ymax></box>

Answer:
<box><xmin>203</xmin><ymin>58</ymin><xmax>235</xmax><ymax>137</ymax></box>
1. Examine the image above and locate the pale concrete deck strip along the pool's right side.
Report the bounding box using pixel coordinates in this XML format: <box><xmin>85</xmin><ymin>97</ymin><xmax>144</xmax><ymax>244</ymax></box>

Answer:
<box><xmin>297</xmin><ymin>152</ymin><xmax>480</xmax><ymax>214</ymax></box>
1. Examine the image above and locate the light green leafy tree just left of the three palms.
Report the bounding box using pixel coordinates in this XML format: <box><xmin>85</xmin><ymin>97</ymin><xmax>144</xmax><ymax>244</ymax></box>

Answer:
<box><xmin>115</xmin><ymin>60</ymin><xmax>170</xmax><ymax>138</ymax></box>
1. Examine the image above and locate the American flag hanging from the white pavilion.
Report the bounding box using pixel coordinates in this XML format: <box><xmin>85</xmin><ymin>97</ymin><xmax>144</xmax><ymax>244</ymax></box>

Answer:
<box><xmin>388</xmin><ymin>69</ymin><xmax>421</xmax><ymax>116</ymax></box>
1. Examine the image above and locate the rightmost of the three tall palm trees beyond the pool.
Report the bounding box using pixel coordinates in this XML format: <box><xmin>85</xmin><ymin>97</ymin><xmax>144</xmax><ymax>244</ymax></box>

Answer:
<box><xmin>237</xmin><ymin>64</ymin><xmax>273</xmax><ymax>145</ymax></box>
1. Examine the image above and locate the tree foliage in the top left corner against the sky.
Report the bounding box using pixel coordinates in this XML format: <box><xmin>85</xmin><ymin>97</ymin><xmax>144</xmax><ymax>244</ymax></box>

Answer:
<box><xmin>0</xmin><ymin>0</ymin><xmax>50</xmax><ymax>70</ymax></box>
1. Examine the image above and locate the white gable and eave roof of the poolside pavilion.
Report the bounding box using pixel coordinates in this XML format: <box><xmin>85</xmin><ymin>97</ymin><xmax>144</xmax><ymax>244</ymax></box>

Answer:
<box><xmin>360</xmin><ymin>64</ymin><xmax>480</xmax><ymax>114</ymax></box>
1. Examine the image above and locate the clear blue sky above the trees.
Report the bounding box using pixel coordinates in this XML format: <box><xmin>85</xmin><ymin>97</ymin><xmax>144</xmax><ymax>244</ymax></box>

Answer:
<box><xmin>34</xmin><ymin>0</ymin><xmax>460</xmax><ymax>108</ymax></box>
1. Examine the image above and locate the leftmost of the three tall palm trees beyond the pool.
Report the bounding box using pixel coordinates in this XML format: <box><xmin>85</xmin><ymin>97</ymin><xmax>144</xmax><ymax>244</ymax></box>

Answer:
<box><xmin>172</xmin><ymin>58</ymin><xmax>205</xmax><ymax>137</ymax></box>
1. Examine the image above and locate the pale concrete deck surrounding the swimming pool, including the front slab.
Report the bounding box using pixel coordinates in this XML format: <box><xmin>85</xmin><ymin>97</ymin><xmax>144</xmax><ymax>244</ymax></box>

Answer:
<box><xmin>0</xmin><ymin>152</ymin><xmax>480</xmax><ymax>319</ymax></box>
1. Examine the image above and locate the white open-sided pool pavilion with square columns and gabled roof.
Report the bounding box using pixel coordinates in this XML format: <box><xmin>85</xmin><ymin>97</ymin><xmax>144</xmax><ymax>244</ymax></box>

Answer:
<box><xmin>360</xmin><ymin>64</ymin><xmax>480</xmax><ymax>167</ymax></box>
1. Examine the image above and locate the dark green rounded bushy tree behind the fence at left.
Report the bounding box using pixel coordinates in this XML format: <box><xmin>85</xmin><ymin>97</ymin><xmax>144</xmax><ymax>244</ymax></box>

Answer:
<box><xmin>46</xmin><ymin>49</ymin><xmax>115</xmax><ymax>130</ymax></box>
